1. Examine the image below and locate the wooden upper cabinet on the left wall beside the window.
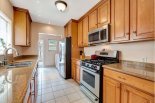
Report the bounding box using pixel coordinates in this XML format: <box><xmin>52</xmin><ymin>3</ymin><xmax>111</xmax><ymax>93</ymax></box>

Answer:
<box><xmin>14</xmin><ymin>7</ymin><xmax>32</xmax><ymax>46</ymax></box>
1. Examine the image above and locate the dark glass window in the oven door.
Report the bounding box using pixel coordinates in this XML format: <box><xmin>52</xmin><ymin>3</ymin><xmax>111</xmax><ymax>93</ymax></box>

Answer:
<box><xmin>83</xmin><ymin>70</ymin><xmax>95</xmax><ymax>88</ymax></box>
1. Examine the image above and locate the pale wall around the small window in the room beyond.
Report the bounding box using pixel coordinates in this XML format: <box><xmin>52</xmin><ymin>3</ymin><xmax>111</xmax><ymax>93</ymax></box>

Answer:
<box><xmin>39</xmin><ymin>34</ymin><xmax>61</xmax><ymax>66</ymax></box>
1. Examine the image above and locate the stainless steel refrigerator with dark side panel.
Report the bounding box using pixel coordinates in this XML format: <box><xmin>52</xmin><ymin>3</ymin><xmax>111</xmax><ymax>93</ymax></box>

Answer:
<box><xmin>59</xmin><ymin>37</ymin><xmax>71</xmax><ymax>79</ymax></box>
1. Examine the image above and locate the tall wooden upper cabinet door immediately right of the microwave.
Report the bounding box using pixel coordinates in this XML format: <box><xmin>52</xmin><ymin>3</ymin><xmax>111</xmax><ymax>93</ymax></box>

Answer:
<box><xmin>111</xmin><ymin>0</ymin><xmax>130</xmax><ymax>41</ymax></box>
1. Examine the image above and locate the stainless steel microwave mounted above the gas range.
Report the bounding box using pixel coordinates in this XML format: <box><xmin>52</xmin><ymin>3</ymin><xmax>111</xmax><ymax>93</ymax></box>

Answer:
<box><xmin>88</xmin><ymin>24</ymin><xmax>110</xmax><ymax>45</ymax></box>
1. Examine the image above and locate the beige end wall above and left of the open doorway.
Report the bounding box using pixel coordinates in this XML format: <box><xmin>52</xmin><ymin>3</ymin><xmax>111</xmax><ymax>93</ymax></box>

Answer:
<box><xmin>22</xmin><ymin>22</ymin><xmax>64</xmax><ymax>55</ymax></box>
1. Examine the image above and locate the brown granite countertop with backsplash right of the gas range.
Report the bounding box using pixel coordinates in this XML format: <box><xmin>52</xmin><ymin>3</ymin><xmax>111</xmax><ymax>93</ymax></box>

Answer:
<box><xmin>103</xmin><ymin>62</ymin><xmax>155</xmax><ymax>82</ymax></box>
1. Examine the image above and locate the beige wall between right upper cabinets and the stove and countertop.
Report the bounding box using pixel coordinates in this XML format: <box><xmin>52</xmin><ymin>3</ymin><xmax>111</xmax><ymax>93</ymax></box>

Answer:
<box><xmin>84</xmin><ymin>41</ymin><xmax>155</xmax><ymax>63</ymax></box>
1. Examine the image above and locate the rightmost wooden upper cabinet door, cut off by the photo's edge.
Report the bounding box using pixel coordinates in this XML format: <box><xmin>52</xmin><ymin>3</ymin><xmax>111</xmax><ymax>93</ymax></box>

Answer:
<box><xmin>131</xmin><ymin>0</ymin><xmax>155</xmax><ymax>39</ymax></box>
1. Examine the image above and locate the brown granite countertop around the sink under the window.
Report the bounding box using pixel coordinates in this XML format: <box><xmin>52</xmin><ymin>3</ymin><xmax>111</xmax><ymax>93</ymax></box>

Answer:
<box><xmin>0</xmin><ymin>57</ymin><xmax>38</xmax><ymax>103</ymax></box>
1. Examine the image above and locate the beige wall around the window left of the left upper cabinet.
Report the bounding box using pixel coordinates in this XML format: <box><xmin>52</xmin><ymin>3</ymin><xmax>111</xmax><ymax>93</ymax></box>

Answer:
<box><xmin>0</xmin><ymin>0</ymin><xmax>22</xmax><ymax>56</ymax></box>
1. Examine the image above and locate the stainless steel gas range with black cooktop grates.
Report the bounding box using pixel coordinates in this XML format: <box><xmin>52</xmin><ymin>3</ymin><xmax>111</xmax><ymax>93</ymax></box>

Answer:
<box><xmin>80</xmin><ymin>51</ymin><xmax>119</xmax><ymax>103</ymax></box>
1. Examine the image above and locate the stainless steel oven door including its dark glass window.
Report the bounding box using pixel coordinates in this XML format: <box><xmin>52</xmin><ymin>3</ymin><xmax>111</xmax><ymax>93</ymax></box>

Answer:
<box><xmin>81</xmin><ymin>66</ymin><xmax>100</xmax><ymax>97</ymax></box>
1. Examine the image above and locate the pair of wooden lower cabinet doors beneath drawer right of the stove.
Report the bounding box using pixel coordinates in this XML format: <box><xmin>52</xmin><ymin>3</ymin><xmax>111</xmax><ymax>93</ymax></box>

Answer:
<box><xmin>103</xmin><ymin>77</ymin><xmax>154</xmax><ymax>103</ymax></box>
